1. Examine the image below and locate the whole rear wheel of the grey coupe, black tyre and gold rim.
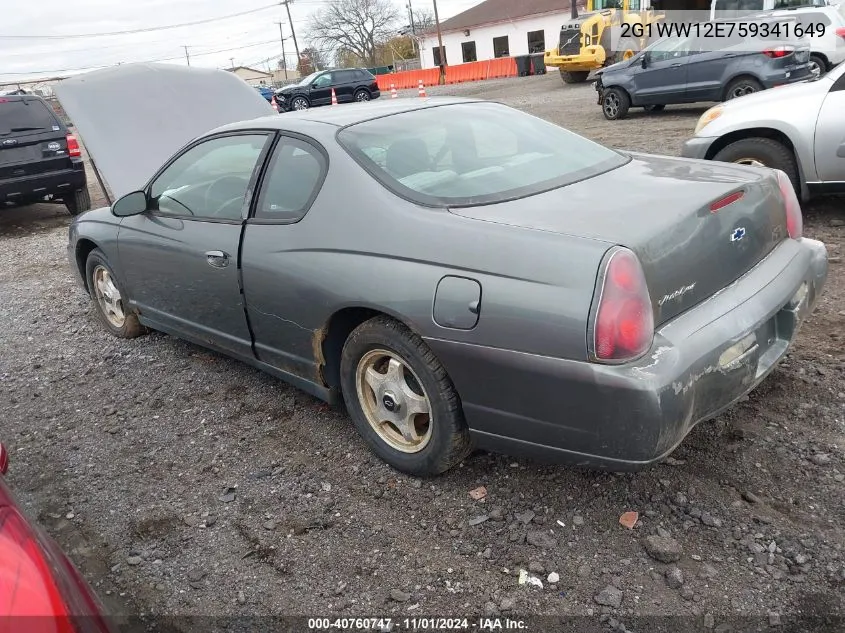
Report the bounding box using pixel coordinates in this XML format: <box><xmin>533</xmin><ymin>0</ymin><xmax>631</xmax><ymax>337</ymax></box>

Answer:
<box><xmin>340</xmin><ymin>317</ymin><xmax>471</xmax><ymax>476</ymax></box>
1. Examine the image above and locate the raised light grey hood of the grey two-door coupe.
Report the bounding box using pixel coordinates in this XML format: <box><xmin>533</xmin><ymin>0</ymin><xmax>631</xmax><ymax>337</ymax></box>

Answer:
<box><xmin>54</xmin><ymin>64</ymin><xmax>274</xmax><ymax>199</ymax></box>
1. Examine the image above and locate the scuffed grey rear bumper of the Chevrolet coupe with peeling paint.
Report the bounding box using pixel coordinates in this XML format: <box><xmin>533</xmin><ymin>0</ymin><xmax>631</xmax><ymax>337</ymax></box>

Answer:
<box><xmin>428</xmin><ymin>239</ymin><xmax>827</xmax><ymax>470</ymax></box>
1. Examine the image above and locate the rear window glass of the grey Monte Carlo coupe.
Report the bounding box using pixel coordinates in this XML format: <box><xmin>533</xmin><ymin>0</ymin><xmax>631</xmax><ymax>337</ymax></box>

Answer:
<box><xmin>338</xmin><ymin>103</ymin><xmax>629</xmax><ymax>206</ymax></box>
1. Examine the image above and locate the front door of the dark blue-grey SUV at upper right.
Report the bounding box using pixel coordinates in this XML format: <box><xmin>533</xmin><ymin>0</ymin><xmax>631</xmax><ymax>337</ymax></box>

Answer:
<box><xmin>632</xmin><ymin>38</ymin><xmax>692</xmax><ymax>105</ymax></box>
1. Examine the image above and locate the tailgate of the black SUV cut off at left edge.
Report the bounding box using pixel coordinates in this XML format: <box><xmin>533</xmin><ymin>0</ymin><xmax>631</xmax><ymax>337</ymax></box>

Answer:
<box><xmin>0</xmin><ymin>96</ymin><xmax>70</xmax><ymax>180</ymax></box>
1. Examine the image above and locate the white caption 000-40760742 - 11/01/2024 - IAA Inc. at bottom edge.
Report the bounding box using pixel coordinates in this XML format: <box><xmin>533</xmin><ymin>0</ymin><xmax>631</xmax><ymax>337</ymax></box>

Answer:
<box><xmin>308</xmin><ymin>617</ymin><xmax>527</xmax><ymax>633</ymax></box>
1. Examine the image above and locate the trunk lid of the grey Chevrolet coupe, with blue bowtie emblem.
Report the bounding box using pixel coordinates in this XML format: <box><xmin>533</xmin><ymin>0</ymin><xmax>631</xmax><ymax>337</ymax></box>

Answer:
<box><xmin>450</xmin><ymin>154</ymin><xmax>788</xmax><ymax>325</ymax></box>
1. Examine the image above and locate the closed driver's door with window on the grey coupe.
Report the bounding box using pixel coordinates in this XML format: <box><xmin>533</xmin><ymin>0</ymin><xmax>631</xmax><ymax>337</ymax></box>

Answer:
<box><xmin>118</xmin><ymin>132</ymin><xmax>270</xmax><ymax>355</ymax></box>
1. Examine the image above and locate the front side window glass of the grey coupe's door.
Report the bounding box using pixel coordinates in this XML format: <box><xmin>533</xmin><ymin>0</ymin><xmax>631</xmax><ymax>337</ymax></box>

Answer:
<box><xmin>150</xmin><ymin>134</ymin><xmax>267</xmax><ymax>220</ymax></box>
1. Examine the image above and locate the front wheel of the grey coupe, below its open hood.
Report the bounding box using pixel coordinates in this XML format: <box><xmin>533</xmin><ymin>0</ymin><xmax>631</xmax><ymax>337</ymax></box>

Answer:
<box><xmin>85</xmin><ymin>248</ymin><xmax>145</xmax><ymax>338</ymax></box>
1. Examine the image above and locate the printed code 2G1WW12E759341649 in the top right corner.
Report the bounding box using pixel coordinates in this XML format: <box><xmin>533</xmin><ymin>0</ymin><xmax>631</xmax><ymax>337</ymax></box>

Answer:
<box><xmin>618</xmin><ymin>21</ymin><xmax>825</xmax><ymax>40</ymax></box>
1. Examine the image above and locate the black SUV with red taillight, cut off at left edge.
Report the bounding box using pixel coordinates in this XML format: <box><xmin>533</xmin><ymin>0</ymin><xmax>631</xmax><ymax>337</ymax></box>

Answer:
<box><xmin>0</xmin><ymin>95</ymin><xmax>91</xmax><ymax>215</ymax></box>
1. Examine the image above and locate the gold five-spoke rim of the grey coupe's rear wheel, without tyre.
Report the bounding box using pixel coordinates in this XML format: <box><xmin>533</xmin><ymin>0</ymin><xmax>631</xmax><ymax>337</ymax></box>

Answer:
<box><xmin>355</xmin><ymin>349</ymin><xmax>432</xmax><ymax>453</ymax></box>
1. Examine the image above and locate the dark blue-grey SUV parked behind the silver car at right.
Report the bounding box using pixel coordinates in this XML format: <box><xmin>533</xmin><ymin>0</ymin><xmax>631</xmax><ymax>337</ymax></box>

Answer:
<box><xmin>595</xmin><ymin>30</ymin><xmax>814</xmax><ymax>121</ymax></box>
